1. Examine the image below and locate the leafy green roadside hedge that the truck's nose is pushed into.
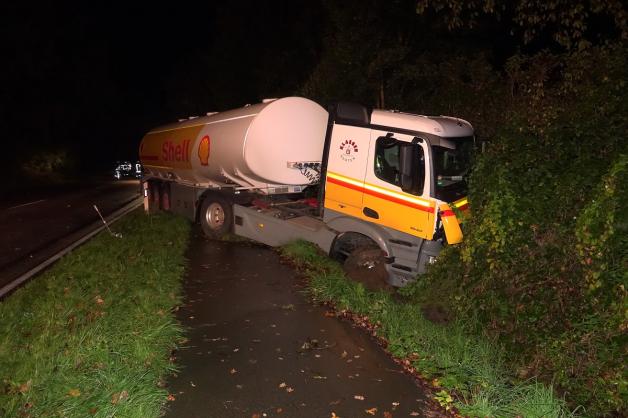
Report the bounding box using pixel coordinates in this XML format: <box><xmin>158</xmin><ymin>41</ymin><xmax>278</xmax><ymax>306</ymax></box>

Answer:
<box><xmin>406</xmin><ymin>45</ymin><xmax>628</xmax><ymax>416</ymax></box>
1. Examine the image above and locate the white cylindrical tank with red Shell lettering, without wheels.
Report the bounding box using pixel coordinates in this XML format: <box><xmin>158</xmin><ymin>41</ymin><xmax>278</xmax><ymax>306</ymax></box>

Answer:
<box><xmin>140</xmin><ymin>97</ymin><xmax>328</xmax><ymax>193</ymax></box>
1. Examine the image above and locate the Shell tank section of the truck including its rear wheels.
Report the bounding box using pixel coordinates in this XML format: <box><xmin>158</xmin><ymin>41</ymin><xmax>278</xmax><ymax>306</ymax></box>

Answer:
<box><xmin>140</xmin><ymin>97</ymin><xmax>328</xmax><ymax>236</ymax></box>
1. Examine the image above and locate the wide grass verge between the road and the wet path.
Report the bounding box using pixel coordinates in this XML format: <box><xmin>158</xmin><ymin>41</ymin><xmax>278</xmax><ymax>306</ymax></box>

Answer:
<box><xmin>0</xmin><ymin>211</ymin><xmax>189</xmax><ymax>418</ymax></box>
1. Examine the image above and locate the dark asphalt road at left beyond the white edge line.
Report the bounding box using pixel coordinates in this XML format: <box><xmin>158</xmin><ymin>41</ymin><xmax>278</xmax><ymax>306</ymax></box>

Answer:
<box><xmin>0</xmin><ymin>180</ymin><xmax>139</xmax><ymax>287</ymax></box>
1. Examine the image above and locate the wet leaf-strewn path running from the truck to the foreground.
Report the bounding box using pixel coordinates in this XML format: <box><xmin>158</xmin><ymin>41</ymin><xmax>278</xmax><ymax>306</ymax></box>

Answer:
<box><xmin>166</xmin><ymin>231</ymin><xmax>445</xmax><ymax>418</ymax></box>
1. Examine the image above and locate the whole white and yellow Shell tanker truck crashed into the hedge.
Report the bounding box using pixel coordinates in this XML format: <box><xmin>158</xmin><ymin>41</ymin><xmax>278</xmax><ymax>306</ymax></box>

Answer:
<box><xmin>139</xmin><ymin>97</ymin><xmax>474</xmax><ymax>287</ymax></box>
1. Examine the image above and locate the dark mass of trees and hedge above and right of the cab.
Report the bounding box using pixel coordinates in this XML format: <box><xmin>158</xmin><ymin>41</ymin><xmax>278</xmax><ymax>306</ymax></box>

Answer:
<box><xmin>303</xmin><ymin>1</ymin><xmax>628</xmax><ymax>416</ymax></box>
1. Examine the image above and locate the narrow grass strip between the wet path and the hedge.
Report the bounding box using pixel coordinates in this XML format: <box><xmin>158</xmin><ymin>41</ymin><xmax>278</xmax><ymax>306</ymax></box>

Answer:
<box><xmin>280</xmin><ymin>241</ymin><xmax>576</xmax><ymax>418</ymax></box>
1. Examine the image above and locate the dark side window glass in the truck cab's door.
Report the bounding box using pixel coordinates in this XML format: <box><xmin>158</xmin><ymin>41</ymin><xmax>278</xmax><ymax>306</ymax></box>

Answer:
<box><xmin>375</xmin><ymin>136</ymin><xmax>425</xmax><ymax>194</ymax></box>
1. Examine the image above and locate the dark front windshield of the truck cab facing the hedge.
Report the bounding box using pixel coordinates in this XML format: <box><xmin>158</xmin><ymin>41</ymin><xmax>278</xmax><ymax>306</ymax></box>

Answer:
<box><xmin>432</xmin><ymin>137</ymin><xmax>474</xmax><ymax>202</ymax></box>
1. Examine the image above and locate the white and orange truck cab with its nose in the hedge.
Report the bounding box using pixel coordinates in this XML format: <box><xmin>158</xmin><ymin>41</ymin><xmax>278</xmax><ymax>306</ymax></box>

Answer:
<box><xmin>323</xmin><ymin>104</ymin><xmax>474</xmax><ymax>286</ymax></box>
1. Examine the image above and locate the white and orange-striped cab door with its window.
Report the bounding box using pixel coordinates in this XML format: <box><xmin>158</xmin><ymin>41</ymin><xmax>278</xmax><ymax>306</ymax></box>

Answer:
<box><xmin>361</xmin><ymin>130</ymin><xmax>436</xmax><ymax>239</ymax></box>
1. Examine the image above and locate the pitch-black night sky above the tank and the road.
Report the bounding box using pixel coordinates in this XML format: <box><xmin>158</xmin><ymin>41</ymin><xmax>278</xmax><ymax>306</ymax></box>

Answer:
<box><xmin>0</xmin><ymin>0</ymin><xmax>324</xmax><ymax>169</ymax></box>
